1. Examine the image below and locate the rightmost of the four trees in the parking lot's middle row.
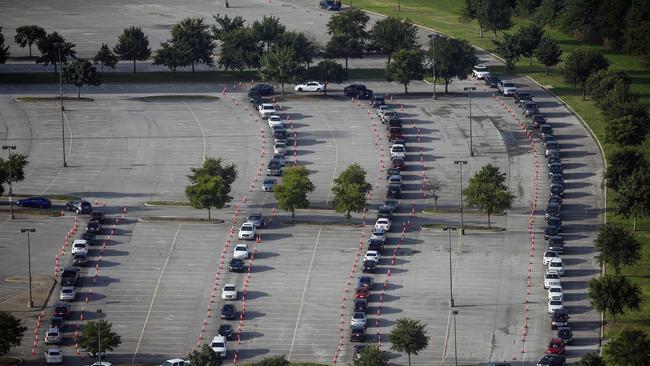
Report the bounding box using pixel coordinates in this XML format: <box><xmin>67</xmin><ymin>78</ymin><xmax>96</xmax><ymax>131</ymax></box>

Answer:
<box><xmin>463</xmin><ymin>164</ymin><xmax>515</xmax><ymax>228</ymax></box>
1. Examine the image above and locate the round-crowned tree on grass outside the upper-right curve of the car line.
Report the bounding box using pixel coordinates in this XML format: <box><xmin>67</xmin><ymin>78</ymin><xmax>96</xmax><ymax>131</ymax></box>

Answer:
<box><xmin>564</xmin><ymin>46</ymin><xmax>609</xmax><ymax>100</ymax></box>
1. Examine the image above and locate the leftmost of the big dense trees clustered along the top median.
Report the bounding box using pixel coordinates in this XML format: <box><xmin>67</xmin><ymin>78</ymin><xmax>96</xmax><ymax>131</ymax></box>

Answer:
<box><xmin>171</xmin><ymin>18</ymin><xmax>215</xmax><ymax>72</ymax></box>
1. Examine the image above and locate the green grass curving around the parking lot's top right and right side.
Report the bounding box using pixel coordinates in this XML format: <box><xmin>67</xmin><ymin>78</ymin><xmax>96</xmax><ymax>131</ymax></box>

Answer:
<box><xmin>346</xmin><ymin>0</ymin><xmax>650</xmax><ymax>334</ymax></box>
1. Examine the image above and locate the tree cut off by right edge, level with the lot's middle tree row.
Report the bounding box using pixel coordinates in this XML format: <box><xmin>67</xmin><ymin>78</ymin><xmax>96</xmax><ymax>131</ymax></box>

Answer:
<box><xmin>614</xmin><ymin>168</ymin><xmax>650</xmax><ymax>232</ymax></box>
